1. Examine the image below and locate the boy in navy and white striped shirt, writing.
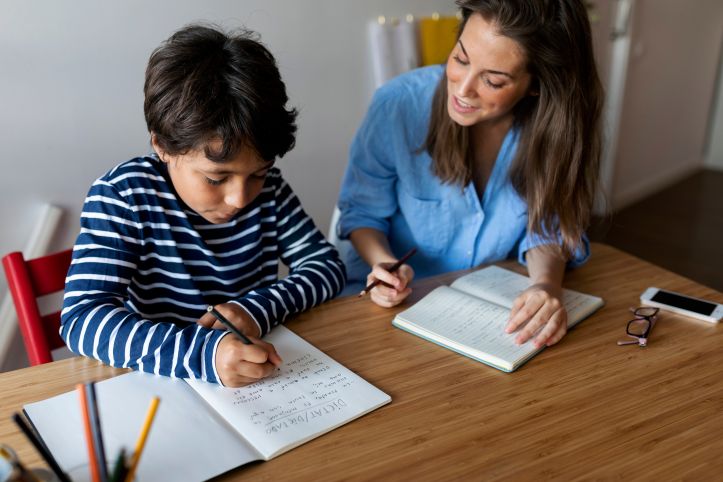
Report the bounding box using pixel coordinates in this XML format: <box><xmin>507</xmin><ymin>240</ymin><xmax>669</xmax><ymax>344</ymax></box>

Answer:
<box><xmin>60</xmin><ymin>26</ymin><xmax>346</xmax><ymax>386</ymax></box>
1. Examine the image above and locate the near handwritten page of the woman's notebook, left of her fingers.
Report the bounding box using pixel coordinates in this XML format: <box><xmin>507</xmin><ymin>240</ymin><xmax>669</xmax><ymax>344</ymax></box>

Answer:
<box><xmin>396</xmin><ymin>286</ymin><xmax>538</xmax><ymax>368</ymax></box>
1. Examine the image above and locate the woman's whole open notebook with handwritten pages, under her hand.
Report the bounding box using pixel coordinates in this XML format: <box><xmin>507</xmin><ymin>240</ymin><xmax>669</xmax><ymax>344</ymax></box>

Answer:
<box><xmin>392</xmin><ymin>266</ymin><xmax>604</xmax><ymax>372</ymax></box>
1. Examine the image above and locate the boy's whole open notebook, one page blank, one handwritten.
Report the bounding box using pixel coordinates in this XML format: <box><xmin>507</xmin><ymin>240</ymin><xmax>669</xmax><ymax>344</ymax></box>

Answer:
<box><xmin>24</xmin><ymin>326</ymin><xmax>391</xmax><ymax>482</ymax></box>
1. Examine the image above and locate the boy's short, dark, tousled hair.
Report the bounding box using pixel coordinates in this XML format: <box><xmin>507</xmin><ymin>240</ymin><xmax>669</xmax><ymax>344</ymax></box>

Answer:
<box><xmin>143</xmin><ymin>25</ymin><xmax>297</xmax><ymax>162</ymax></box>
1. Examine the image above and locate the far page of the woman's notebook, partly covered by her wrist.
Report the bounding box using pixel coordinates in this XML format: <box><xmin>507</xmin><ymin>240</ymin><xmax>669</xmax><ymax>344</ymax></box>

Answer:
<box><xmin>451</xmin><ymin>266</ymin><xmax>603</xmax><ymax>326</ymax></box>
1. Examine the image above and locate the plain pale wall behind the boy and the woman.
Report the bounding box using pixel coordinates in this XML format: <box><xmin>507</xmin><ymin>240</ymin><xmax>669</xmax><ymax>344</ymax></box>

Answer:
<box><xmin>0</xmin><ymin>0</ymin><xmax>455</xmax><ymax>370</ymax></box>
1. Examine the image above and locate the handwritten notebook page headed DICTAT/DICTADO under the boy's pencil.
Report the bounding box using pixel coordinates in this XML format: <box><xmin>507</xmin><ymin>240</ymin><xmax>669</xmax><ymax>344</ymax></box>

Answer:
<box><xmin>189</xmin><ymin>326</ymin><xmax>391</xmax><ymax>459</ymax></box>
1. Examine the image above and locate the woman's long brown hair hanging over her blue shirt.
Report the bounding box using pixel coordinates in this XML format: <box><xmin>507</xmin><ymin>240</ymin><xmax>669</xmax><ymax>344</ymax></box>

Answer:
<box><xmin>422</xmin><ymin>0</ymin><xmax>603</xmax><ymax>256</ymax></box>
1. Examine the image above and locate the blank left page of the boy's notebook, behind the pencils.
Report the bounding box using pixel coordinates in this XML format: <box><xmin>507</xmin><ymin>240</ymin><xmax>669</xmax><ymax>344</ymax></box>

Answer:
<box><xmin>24</xmin><ymin>372</ymin><xmax>261</xmax><ymax>482</ymax></box>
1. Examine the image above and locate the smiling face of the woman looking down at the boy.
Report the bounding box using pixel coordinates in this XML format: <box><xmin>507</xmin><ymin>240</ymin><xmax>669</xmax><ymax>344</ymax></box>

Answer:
<box><xmin>447</xmin><ymin>14</ymin><xmax>531</xmax><ymax>126</ymax></box>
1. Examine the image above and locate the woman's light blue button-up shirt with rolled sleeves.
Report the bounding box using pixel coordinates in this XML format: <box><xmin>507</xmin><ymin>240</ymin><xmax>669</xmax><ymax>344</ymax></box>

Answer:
<box><xmin>337</xmin><ymin>66</ymin><xmax>589</xmax><ymax>290</ymax></box>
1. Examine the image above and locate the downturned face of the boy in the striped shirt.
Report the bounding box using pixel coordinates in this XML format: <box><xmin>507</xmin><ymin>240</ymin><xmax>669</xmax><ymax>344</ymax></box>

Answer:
<box><xmin>152</xmin><ymin>139</ymin><xmax>273</xmax><ymax>224</ymax></box>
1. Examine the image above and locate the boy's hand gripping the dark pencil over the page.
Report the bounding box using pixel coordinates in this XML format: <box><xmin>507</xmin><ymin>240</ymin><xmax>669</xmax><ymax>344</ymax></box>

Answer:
<box><xmin>216</xmin><ymin>334</ymin><xmax>281</xmax><ymax>387</ymax></box>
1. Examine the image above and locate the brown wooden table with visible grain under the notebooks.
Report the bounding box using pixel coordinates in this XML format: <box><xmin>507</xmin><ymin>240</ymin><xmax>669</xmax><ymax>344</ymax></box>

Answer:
<box><xmin>0</xmin><ymin>244</ymin><xmax>723</xmax><ymax>481</ymax></box>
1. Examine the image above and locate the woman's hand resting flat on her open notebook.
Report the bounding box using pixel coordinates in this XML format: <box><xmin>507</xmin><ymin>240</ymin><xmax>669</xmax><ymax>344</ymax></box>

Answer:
<box><xmin>505</xmin><ymin>283</ymin><xmax>567</xmax><ymax>348</ymax></box>
